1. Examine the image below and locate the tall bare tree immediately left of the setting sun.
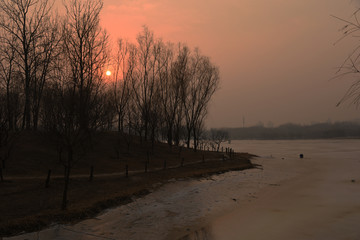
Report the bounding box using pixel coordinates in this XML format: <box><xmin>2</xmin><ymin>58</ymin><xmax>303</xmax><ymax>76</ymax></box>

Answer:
<box><xmin>63</xmin><ymin>0</ymin><xmax>108</xmax><ymax>129</ymax></box>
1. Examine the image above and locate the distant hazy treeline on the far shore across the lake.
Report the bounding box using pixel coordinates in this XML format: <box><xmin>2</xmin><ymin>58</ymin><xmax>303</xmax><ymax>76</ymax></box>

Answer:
<box><xmin>223</xmin><ymin>122</ymin><xmax>360</xmax><ymax>140</ymax></box>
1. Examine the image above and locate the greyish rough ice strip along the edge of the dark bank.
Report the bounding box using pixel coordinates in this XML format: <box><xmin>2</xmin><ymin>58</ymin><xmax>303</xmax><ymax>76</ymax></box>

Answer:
<box><xmin>6</xmin><ymin>155</ymin><xmax>293</xmax><ymax>240</ymax></box>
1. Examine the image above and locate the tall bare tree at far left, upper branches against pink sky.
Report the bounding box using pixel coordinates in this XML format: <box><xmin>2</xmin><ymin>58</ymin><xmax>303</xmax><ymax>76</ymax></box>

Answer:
<box><xmin>0</xmin><ymin>0</ymin><xmax>52</xmax><ymax>129</ymax></box>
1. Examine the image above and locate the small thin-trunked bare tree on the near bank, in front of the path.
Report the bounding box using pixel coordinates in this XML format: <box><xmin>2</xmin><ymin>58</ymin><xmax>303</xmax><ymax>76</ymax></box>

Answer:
<box><xmin>43</xmin><ymin>79</ymin><xmax>90</xmax><ymax>210</ymax></box>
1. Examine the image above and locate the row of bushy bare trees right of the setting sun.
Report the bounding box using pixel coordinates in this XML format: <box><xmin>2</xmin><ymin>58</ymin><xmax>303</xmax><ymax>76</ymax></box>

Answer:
<box><xmin>109</xmin><ymin>27</ymin><xmax>219</xmax><ymax>148</ymax></box>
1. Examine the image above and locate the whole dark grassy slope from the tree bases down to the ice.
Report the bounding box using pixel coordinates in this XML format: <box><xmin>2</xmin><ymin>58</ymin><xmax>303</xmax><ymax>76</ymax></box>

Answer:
<box><xmin>0</xmin><ymin>133</ymin><xmax>252</xmax><ymax>236</ymax></box>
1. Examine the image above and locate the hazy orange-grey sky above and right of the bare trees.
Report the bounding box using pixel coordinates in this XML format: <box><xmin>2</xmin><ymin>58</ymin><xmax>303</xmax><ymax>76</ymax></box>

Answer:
<box><xmin>97</xmin><ymin>0</ymin><xmax>360</xmax><ymax>127</ymax></box>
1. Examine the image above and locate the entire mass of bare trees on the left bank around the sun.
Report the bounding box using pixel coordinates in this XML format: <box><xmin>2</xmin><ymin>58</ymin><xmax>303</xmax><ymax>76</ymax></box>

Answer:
<box><xmin>0</xmin><ymin>0</ymin><xmax>219</xmax><ymax>208</ymax></box>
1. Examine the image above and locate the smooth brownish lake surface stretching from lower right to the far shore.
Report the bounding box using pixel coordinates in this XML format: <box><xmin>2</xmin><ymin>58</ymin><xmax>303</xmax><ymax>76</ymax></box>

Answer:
<box><xmin>183</xmin><ymin>139</ymin><xmax>360</xmax><ymax>240</ymax></box>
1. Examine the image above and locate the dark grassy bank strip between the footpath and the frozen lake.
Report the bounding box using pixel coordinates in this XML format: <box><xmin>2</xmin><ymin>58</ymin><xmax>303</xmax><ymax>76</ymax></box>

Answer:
<box><xmin>0</xmin><ymin>153</ymin><xmax>253</xmax><ymax>236</ymax></box>
